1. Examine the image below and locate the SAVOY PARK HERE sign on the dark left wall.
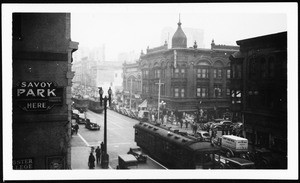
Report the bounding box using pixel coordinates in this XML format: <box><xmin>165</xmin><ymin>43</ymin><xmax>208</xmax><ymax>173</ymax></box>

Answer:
<box><xmin>13</xmin><ymin>81</ymin><xmax>63</xmax><ymax>111</ymax></box>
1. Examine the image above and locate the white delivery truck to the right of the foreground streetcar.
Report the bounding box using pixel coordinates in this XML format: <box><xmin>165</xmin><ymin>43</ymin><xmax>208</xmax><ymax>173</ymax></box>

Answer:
<box><xmin>221</xmin><ymin>135</ymin><xmax>248</xmax><ymax>158</ymax></box>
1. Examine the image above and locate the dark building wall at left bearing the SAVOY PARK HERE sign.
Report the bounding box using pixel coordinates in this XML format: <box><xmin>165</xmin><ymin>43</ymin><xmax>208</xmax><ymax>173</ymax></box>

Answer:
<box><xmin>12</xmin><ymin>13</ymin><xmax>78</xmax><ymax>169</ymax></box>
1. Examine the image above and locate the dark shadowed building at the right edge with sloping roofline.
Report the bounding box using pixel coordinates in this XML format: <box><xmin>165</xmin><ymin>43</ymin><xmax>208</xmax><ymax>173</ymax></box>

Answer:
<box><xmin>230</xmin><ymin>32</ymin><xmax>288</xmax><ymax>168</ymax></box>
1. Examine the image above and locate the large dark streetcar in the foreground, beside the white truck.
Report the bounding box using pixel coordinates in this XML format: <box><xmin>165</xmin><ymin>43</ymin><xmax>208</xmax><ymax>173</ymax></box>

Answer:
<box><xmin>134</xmin><ymin>122</ymin><xmax>221</xmax><ymax>169</ymax></box>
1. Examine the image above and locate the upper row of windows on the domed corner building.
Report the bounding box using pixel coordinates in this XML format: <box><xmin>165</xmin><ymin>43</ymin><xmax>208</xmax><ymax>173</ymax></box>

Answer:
<box><xmin>142</xmin><ymin>68</ymin><xmax>230</xmax><ymax>79</ymax></box>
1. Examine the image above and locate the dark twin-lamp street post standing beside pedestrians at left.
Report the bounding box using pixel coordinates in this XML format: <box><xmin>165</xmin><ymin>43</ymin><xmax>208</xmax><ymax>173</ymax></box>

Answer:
<box><xmin>99</xmin><ymin>87</ymin><xmax>112</xmax><ymax>168</ymax></box>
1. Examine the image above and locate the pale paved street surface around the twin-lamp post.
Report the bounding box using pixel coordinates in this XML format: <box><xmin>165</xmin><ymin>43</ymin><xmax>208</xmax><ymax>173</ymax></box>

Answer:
<box><xmin>71</xmin><ymin>110</ymin><xmax>138</xmax><ymax>169</ymax></box>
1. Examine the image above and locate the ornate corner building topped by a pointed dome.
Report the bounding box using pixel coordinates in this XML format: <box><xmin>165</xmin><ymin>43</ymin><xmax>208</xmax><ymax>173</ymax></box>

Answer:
<box><xmin>138</xmin><ymin>22</ymin><xmax>238</xmax><ymax>120</ymax></box>
